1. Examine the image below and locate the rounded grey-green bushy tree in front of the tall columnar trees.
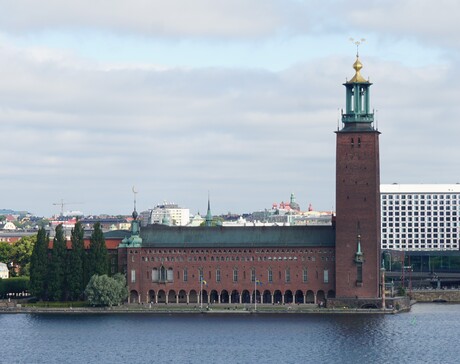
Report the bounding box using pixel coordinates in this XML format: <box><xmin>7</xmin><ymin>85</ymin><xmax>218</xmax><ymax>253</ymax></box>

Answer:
<box><xmin>85</xmin><ymin>273</ymin><xmax>128</xmax><ymax>306</ymax></box>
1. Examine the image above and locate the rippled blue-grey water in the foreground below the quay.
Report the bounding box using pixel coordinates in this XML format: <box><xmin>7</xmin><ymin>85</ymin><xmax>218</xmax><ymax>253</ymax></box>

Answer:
<box><xmin>0</xmin><ymin>304</ymin><xmax>460</xmax><ymax>364</ymax></box>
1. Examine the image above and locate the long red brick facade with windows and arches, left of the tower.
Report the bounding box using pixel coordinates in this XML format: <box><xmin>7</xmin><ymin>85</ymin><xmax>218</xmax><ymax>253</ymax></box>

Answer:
<box><xmin>124</xmin><ymin>247</ymin><xmax>335</xmax><ymax>304</ymax></box>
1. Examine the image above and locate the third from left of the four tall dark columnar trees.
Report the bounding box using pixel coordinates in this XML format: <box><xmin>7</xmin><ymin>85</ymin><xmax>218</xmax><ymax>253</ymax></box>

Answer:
<box><xmin>66</xmin><ymin>221</ymin><xmax>85</xmax><ymax>301</ymax></box>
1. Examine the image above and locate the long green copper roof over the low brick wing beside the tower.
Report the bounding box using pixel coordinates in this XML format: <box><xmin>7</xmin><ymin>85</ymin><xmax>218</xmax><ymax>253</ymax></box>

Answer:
<box><xmin>141</xmin><ymin>225</ymin><xmax>335</xmax><ymax>248</ymax></box>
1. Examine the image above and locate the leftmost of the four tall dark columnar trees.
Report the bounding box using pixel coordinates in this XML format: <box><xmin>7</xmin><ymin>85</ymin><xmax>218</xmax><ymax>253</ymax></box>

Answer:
<box><xmin>30</xmin><ymin>228</ymin><xmax>50</xmax><ymax>299</ymax></box>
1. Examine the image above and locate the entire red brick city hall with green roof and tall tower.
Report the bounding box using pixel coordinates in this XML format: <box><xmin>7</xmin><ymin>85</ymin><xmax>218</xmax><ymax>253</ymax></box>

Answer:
<box><xmin>118</xmin><ymin>56</ymin><xmax>382</xmax><ymax>307</ymax></box>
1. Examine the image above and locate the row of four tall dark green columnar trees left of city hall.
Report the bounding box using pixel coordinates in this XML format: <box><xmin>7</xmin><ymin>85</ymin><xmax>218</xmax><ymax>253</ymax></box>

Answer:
<box><xmin>29</xmin><ymin>222</ymin><xmax>109</xmax><ymax>301</ymax></box>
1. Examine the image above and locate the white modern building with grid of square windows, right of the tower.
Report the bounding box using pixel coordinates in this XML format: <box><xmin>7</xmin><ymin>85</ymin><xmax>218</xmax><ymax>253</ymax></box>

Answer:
<box><xmin>380</xmin><ymin>184</ymin><xmax>460</xmax><ymax>251</ymax></box>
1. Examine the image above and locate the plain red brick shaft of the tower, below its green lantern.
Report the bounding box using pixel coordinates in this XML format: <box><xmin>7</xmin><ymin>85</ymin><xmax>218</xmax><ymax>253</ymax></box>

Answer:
<box><xmin>336</xmin><ymin>131</ymin><xmax>380</xmax><ymax>298</ymax></box>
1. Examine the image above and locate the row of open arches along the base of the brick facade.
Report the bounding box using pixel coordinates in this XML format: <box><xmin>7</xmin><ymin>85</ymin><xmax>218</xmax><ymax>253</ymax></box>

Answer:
<box><xmin>128</xmin><ymin>289</ymin><xmax>335</xmax><ymax>304</ymax></box>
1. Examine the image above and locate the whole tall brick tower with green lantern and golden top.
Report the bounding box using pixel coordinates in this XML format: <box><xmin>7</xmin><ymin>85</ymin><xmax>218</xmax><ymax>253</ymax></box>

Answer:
<box><xmin>335</xmin><ymin>54</ymin><xmax>380</xmax><ymax>305</ymax></box>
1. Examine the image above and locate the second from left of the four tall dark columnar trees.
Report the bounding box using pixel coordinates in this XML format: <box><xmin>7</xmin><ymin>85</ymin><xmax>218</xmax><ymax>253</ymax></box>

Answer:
<box><xmin>48</xmin><ymin>224</ymin><xmax>67</xmax><ymax>301</ymax></box>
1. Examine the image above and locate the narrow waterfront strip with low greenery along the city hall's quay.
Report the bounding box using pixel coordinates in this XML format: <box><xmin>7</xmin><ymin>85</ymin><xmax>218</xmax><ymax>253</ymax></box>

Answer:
<box><xmin>0</xmin><ymin>302</ymin><xmax>406</xmax><ymax>315</ymax></box>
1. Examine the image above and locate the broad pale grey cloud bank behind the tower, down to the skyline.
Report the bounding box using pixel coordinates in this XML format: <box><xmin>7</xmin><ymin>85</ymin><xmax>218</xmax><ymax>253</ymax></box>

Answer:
<box><xmin>0</xmin><ymin>45</ymin><xmax>460</xmax><ymax>214</ymax></box>
